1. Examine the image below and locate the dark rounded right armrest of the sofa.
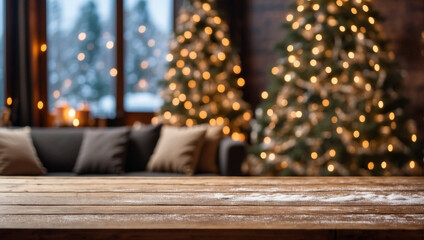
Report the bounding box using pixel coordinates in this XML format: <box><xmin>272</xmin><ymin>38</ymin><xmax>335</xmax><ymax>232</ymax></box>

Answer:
<box><xmin>218</xmin><ymin>137</ymin><xmax>247</xmax><ymax>176</ymax></box>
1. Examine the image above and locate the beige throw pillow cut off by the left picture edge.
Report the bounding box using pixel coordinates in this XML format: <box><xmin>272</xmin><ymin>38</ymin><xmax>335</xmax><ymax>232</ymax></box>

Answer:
<box><xmin>0</xmin><ymin>127</ymin><xmax>46</xmax><ymax>175</ymax></box>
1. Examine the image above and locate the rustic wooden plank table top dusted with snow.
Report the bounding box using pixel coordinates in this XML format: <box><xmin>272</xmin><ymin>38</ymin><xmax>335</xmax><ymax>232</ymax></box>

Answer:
<box><xmin>0</xmin><ymin>177</ymin><xmax>424</xmax><ymax>231</ymax></box>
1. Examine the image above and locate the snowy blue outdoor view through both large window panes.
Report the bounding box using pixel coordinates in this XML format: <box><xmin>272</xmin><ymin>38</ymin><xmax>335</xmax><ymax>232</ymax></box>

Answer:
<box><xmin>47</xmin><ymin>0</ymin><xmax>172</xmax><ymax>118</ymax></box>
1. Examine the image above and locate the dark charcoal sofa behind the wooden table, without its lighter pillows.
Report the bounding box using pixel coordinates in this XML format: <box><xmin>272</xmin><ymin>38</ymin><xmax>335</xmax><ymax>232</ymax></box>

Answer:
<box><xmin>24</xmin><ymin>125</ymin><xmax>247</xmax><ymax>177</ymax></box>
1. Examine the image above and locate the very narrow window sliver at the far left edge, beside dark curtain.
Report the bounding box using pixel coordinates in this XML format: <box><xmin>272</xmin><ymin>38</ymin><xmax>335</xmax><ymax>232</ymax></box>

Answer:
<box><xmin>0</xmin><ymin>0</ymin><xmax>6</xmax><ymax>109</ymax></box>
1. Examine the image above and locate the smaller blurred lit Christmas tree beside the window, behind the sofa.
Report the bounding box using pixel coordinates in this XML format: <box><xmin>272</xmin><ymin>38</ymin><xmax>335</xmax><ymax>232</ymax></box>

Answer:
<box><xmin>154</xmin><ymin>0</ymin><xmax>251</xmax><ymax>140</ymax></box>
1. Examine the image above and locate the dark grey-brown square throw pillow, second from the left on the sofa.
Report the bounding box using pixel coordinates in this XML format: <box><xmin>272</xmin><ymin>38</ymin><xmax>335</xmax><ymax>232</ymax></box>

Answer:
<box><xmin>74</xmin><ymin>127</ymin><xmax>129</xmax><ymax>174</ymax></box>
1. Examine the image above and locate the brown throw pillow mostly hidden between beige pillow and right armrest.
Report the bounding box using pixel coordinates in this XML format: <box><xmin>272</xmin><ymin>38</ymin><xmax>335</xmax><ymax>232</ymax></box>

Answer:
<box><xmin>197</xmin><ymin>126</ymin><xmax>223</xmax><ymax>173</ymax></box>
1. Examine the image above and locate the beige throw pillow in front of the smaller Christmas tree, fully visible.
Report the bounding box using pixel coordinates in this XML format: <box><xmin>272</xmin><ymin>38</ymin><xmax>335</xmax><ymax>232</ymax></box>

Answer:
<box><xmin>147</xmin><ymin>126</ymin><xmax>206</xmax><ymax>175</ymax></box>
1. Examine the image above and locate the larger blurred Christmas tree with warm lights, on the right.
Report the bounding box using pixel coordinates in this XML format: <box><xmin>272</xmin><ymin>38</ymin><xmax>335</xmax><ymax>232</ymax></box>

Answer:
<box><xmin>252</xmin><ymin>0</ymin><xmax>422</xmax><ymax>175</ymax></box>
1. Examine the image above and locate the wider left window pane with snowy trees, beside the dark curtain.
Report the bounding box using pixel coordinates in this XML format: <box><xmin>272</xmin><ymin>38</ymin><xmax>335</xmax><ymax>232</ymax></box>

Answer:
<box><xmin>47</xmin><ymin>0</ymin><xmax>117</xmax><ymax>118</ymax></box>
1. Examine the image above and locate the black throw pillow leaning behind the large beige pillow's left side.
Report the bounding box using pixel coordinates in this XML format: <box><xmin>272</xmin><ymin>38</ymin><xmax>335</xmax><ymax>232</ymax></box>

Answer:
<box><xmin>125</xmin><ymin>124</ymin><xmax>162</xmax><ymax>172</ymax></box>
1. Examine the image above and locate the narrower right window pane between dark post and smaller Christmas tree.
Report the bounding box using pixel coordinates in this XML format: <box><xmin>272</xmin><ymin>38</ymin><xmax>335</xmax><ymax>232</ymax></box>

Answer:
<box><xmin>124</xmin><ymin>0</ymin><xmax>173</xmax><ymax>112</ymax></box>
